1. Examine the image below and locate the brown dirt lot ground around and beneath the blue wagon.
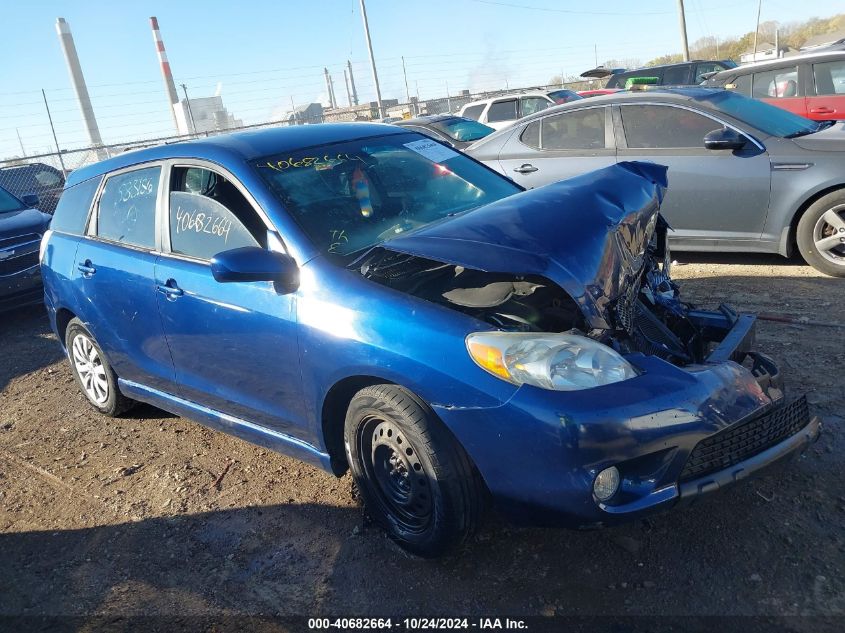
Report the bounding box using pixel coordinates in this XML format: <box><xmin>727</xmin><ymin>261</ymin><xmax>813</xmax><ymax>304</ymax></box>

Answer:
<box><xmin>0</xmin><ymin>256</ymin><xmax>845</xmax><ymax>633</ymax></box>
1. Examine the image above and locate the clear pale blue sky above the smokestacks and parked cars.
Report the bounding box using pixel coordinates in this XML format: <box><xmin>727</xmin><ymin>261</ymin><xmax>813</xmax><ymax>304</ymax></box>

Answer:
<box><xmin>0</xmin><ymin>0</ymin><xmax>836</xmax><ymax>160</ymax></box>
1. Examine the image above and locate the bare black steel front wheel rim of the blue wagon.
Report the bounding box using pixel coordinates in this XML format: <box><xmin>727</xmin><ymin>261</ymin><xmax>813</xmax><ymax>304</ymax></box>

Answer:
<box><xmin>359</xmin><ymin>414</ymin><xmax>433</xmax><ymax>533</ymax></box>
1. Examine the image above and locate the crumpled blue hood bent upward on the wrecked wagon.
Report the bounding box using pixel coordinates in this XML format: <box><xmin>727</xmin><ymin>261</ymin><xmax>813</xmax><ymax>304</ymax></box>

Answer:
<box><xmin>381</xmin><ymin>162</ymin><xmax>667</xmax><ymax>328</ymax></box>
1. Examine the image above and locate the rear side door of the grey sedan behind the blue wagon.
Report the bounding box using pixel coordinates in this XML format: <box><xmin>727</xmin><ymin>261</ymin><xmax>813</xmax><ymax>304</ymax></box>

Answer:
<box><xmin>499</xmin><ymin>106</ymin><xmax>616</xmax><ymax>189</ymax></box>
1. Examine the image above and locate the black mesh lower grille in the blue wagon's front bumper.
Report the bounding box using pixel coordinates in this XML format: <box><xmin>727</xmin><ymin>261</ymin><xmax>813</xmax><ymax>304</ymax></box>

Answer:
<box><xmin>680</xmin><ymin>396</ymin><xmax>810</xmax><ymax>481</ymax></box>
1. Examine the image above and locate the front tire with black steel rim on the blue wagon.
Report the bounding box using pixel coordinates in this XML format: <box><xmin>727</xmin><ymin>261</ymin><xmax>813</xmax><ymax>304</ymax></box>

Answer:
<box><xmin>344</xmin><ymin>385</ymin><xmax>485</xmax><ymax>558</ymax></box>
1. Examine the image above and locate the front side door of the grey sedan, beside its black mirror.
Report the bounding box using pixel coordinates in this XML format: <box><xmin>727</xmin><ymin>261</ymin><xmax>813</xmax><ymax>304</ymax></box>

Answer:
<box><xmin>618</xmin><ymin>104</ymin><xmax>771</xmax><ymax>248</ymax></box>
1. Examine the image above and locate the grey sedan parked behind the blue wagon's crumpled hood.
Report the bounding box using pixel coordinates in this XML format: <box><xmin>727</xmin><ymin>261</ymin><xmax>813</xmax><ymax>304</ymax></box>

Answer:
<box><xmin>466</xmin><ymin>88</ymin><xmax>845</xmax><ymax>277</ymax></box>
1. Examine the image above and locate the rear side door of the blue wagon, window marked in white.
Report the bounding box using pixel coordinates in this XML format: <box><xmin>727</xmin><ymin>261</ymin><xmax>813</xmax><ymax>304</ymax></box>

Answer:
<box><xmin>72</xmin><ymin>164</ymin><xmax>174</xmax><ymax>392</ymax></box>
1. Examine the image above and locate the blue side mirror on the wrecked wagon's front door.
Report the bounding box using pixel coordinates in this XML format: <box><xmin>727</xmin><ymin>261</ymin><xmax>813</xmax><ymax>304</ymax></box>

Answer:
<box><xmin>211</xmin><ymin>246</ymin><xmax>299</xmax><ymax>294</ymax></box>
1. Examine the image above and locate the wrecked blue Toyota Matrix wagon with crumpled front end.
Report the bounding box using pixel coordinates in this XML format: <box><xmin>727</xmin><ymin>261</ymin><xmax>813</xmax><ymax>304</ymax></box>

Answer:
<box><xmin>41</xmin><ymin>124</ymin><xmax>819</xmax><ymax>556</ymax></box>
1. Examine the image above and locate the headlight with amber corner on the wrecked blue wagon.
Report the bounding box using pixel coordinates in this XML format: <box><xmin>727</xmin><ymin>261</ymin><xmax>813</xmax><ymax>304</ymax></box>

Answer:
<box><xmin>466</xmin><ymin>332</ymin><xmax>637</xmax><ymax>391</ymax></box>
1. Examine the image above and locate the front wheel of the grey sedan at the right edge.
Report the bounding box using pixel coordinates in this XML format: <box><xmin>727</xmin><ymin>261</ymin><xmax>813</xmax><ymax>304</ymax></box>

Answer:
<box><xmin>795</xmin><ymin>190</ymin><xmax>845</xmax><ymax>277</ymax></box>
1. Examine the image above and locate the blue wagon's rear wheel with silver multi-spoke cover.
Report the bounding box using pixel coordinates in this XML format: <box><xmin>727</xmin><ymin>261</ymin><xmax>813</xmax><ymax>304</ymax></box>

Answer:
<box><xmin>65</xmin><ymin>318</ymin><xmax>134</xmax><ymax>417</ymax></box>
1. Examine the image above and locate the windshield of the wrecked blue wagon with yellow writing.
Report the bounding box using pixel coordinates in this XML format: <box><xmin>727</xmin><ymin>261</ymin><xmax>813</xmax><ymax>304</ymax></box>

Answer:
<box><xmin>254</xmin><ymin>133</ymin><xmax>522</xmax><ymax>256</ymax></box>
